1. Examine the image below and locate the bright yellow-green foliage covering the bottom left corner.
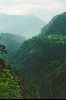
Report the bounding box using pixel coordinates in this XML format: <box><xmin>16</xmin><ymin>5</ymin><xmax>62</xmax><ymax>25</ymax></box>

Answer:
<box><xmin>0</xmin><ymin>69</ymin><xmax>21</xmax><ymax>99</ymax></box>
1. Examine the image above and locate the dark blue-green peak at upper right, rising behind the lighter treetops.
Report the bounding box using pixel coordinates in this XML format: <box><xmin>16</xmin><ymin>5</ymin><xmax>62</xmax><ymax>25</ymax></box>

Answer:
<box><xmin>41</xmin><ymin>12</ymin><xmax>66</xmax><ymax>35</ymax></box>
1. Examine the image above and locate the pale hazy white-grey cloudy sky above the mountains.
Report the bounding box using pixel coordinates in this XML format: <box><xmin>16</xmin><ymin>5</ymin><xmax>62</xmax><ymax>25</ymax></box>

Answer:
<box><xmin>0</xmin><ymin>0</ymin><xmax>66</xmax><ymax>21</ymax></box>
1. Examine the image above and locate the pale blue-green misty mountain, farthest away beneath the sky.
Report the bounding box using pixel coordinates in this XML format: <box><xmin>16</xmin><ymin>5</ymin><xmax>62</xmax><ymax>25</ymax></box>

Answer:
<box><xmin>0</xmin><ymin>15</ymin><xmax>45</xmax><ymax>38</ymax></box>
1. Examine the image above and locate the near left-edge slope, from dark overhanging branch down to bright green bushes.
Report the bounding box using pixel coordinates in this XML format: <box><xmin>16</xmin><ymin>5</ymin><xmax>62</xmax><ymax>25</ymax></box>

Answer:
<box><xmin>0</xmin><ymin>44</ymin><xmax>22</xmax><ymax>99</ymax></box>
